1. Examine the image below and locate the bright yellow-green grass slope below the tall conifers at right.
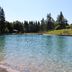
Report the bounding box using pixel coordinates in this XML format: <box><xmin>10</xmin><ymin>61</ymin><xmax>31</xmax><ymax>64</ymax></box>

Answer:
<box><xmin>47</xmin><ymin>29</ymin><xmax>72</xmax><ymax>35</ymax></box>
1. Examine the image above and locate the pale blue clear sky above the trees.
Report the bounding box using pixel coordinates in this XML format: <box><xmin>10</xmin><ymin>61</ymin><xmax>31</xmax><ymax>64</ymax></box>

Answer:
<box><xmin>0</xmin><ymin>0</ymin><xmax>72</xmax><ymax>23</ymax></box>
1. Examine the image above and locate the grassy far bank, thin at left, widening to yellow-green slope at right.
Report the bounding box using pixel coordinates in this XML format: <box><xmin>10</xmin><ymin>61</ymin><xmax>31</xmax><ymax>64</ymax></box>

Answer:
<box><xmin>2</xmin><ymin>29</ymin><xmax>72</xmax><ymax>36</ymax></box>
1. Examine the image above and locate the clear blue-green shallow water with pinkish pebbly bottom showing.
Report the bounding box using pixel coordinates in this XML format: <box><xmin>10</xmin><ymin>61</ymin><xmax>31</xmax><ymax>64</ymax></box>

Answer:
<box><xmin>0</xmin><ymin>34</ymin><xmax>72</xmax><ymax>72</ymax></box>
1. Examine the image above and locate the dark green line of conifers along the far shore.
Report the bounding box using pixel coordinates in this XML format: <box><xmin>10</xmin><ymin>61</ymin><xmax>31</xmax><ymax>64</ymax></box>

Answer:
<box><xmin>0</xmin><ymin>7</ymin><xmax>72</xmax><ymax>34</ymax></box>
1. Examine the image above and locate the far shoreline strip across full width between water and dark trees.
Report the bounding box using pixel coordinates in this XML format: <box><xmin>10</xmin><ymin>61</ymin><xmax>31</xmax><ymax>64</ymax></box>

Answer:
<box><xmin>0</xmin><ymin>30</ymin><xmax>72</xmax><ymax>36</ymax></box>
